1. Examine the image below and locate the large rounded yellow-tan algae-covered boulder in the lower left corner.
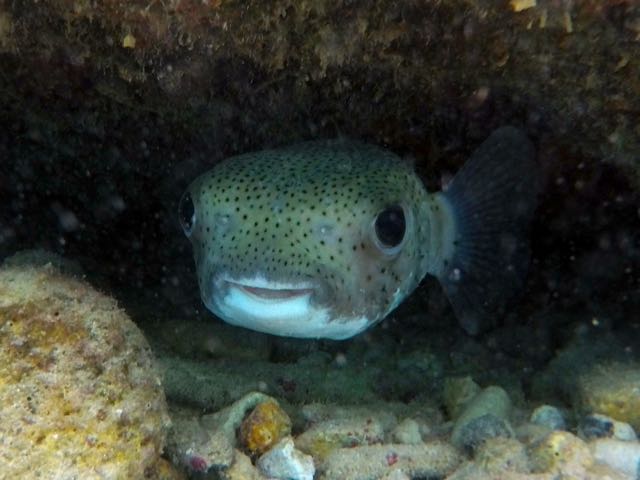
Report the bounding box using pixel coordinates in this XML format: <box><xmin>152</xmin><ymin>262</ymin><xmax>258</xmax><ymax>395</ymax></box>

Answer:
<box><xmin>0</xmin><ymin>266</ymin><xmax>172</xmax><ymax>479</ymax></box>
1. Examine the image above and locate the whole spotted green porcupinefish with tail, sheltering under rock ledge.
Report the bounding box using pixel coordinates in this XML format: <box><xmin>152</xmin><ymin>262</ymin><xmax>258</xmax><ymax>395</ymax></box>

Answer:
<box><xmin>179</xmin><ymin>127</ymin><xmax>538</xmax><ymax>339</ymax></box>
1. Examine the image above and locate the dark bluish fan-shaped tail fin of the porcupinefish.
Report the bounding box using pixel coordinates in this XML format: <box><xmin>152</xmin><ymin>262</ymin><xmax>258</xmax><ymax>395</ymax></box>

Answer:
<box><xmin>437</xmin><ymin>127</ymin><xmax>540</xmax><ymax>335</ymax></box>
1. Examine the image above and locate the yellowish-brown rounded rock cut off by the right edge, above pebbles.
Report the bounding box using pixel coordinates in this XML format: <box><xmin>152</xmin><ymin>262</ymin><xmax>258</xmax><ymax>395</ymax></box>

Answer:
<box><xmin>574</xmin><ymin>362</ymin><xmax>640</xmax><ymax>431</ymax></box>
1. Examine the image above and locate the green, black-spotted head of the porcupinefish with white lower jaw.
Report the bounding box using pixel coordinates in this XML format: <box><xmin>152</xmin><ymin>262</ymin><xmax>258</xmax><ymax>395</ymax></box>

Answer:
<box><xmin>180</xmin><ymin>140</ymin><xmax>429</xmax><ymax>339</ymax></box>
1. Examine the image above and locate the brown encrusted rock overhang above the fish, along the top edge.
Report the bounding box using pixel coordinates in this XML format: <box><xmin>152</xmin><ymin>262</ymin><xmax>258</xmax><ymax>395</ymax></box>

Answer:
<box><xmin>0</xmin><ymin>0</ymin><xmax>640</xmax><ymax>167</ymax></box>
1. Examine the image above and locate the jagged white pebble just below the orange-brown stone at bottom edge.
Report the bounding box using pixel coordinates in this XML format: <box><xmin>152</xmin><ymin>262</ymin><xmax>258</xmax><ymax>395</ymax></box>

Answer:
<box><xmin>257</xmin><ymin>437</ymin><xmax>316</xmax><ymax>480</ymax></box>
